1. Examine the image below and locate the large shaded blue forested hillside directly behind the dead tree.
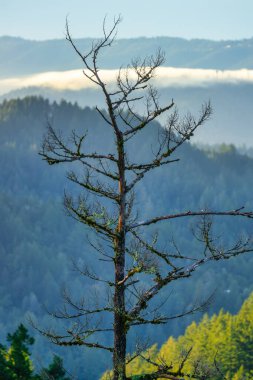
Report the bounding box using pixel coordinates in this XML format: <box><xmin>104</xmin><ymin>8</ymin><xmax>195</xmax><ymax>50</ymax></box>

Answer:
<box><xmin>0</xmin><ymin>97</ymin><xmax>253</xmax><ymax>380</ymax></box>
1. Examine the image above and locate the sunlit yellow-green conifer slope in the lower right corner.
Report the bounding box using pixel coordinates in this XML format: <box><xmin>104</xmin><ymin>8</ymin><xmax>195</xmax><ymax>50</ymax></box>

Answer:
<box><xmin>122</xmin><ymin>293</ymin><xmax>253</xmax><ymax>380</ymax></box>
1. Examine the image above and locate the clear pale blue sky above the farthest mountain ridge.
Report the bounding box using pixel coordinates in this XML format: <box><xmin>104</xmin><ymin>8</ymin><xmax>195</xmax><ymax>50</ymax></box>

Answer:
<box><xmin>0</xmin><ymin>0</ymin><xmax>253</xmax><ymax>40</ymax></box>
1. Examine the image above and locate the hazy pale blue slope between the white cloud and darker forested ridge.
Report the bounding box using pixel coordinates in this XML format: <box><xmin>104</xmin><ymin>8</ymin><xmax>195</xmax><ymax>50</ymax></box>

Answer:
<box><xmin>0</xmin><ymin>82</ymin><xmax>253</xmax><ymax>147</ymax></box>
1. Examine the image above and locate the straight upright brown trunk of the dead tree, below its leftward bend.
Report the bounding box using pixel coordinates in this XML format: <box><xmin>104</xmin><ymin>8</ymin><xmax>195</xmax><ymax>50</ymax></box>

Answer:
<box><xmin>113</xmin><ymin>134</ymin><xmax>126</xmax><ymax>380</ymax></box>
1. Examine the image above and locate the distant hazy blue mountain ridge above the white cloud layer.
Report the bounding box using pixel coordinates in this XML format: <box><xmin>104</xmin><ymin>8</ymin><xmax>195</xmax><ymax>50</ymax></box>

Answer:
<box><xmin>0</xmin><ymin>36</ymin><xmax>253</xmax><ymax>78</ymax></box>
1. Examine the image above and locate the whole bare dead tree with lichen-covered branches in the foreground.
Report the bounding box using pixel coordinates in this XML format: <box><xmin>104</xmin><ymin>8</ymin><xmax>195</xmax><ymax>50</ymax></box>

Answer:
<box><xmin>40</xmin><ymin>18</ymin><xmax>253</xmax><ymax>380</ymax></box>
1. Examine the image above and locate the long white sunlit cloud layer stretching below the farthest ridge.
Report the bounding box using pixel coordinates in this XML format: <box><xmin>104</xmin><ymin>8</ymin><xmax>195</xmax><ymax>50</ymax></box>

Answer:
<box><xmin>0</xmin><ymin>67</ymin><xmax>253</xmax><ymax>95</ymax></box>
